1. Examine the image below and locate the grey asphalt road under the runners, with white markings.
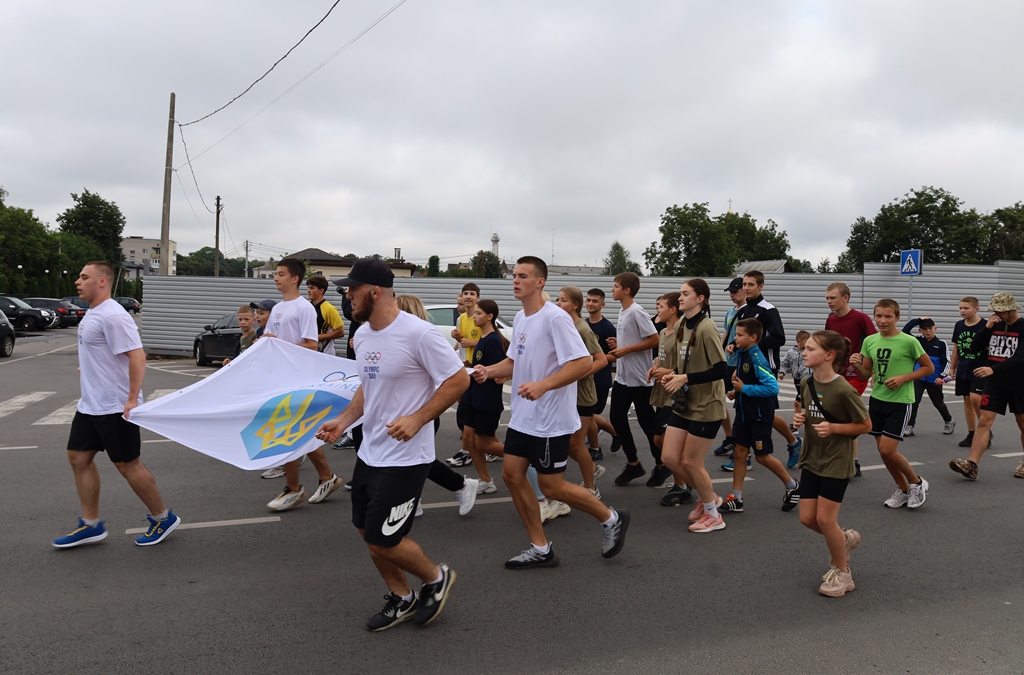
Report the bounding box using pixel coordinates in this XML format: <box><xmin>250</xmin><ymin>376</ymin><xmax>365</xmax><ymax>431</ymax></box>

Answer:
<box><xmin>0</xmin><ymin>329</ymin><xmax>1024</xmax><ymax>673</ymax></box>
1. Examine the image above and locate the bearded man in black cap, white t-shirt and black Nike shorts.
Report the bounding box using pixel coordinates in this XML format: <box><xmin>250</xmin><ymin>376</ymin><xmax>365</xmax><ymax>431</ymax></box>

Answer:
<box><xmin>316</xmin><ymin>258</ymin><xmax>469</xmax><ymax>631</ymax></box>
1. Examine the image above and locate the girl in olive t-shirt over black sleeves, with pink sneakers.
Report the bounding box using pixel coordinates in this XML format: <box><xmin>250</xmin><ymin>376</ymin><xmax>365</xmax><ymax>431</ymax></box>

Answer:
<box><xmin>662</xmin><ymin>279</ymin><xmax>727</xmax><ymax>533</ymax></box>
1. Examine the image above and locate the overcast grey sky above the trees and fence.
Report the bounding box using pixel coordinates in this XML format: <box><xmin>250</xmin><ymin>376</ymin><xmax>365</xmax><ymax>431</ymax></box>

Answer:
<box><xmin>0</xmin><ymin>0</ymin><xmax>1024</xmax><ymax>272</ymax></box>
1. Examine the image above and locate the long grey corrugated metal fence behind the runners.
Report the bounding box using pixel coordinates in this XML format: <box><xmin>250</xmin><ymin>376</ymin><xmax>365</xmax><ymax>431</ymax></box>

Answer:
<box><xmin>142</xmin><ymin>260</ymin><xmax>1024</xmax><ymax>354</ymax></box>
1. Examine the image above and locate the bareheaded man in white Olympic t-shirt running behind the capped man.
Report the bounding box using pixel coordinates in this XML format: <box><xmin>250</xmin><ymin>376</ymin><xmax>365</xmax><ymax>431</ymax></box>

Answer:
<box><xmin>473</xmin><ymin>256</ymin><xmax>630</xmax><ymax>569</ymax></box>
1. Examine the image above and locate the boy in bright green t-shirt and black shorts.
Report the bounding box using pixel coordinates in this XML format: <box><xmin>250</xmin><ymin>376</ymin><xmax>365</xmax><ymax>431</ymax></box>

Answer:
<box><xmin>850</xmin><ymin>298</ymin><xmax>935</xmax><ymax>509</ymax></box>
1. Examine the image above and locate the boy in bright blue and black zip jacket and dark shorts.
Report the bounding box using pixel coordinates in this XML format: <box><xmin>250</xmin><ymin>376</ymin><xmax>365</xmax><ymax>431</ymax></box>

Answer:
<box><xmin>719</xmin><ymin>319</ymin><xmax>800</xmax><ymax>513</ymax></box>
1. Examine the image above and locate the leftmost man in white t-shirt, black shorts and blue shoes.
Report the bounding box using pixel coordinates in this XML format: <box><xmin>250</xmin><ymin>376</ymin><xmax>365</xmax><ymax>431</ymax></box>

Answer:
<box><xmin>53</xmin><ymin>262</ymin><xmax>181</xmax><ymax>548</ymax></box>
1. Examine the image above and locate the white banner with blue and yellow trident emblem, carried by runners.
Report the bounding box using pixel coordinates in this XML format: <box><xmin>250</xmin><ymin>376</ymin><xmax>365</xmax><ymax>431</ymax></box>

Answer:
<box><xmin>129</xmin><ymin>338</ymin><xmax>359</xmax><ymax>470</ymax></box>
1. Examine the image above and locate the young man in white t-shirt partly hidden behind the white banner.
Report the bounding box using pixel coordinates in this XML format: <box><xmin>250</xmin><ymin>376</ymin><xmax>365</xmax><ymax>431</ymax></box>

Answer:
<box><xmin>262</xmin><ymin>258</ymin><xmax>342</xmax><ymax>511</ymax></box>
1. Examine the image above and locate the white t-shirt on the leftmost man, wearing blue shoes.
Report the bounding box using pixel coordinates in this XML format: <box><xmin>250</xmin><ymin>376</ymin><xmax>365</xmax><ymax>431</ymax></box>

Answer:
<box><xmin>78</xmin><ymin>298</ymin><xmax>142</xmax><ymax>415</ymax></box>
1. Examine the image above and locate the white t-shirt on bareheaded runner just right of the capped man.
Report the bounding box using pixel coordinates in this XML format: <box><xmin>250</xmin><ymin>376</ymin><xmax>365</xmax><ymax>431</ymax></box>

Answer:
<box><xmin>506</xmin><ymin>302</ymin><xmax>590</xmax><ymax>438</ymax></box>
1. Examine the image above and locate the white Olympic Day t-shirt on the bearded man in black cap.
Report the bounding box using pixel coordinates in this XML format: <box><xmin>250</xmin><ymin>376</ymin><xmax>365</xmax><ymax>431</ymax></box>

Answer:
<box><xmin>354</xmin><ymin>313</ymin><xmax>463</xmax><ymax>466</ymax></box>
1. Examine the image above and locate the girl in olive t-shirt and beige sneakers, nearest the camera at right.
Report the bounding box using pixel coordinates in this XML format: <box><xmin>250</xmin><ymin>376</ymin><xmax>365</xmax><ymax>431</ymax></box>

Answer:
<box><xmin>793</xmin><ymin>331</ymin><xmax>871</xmax><ymax>597</ymax></box>
